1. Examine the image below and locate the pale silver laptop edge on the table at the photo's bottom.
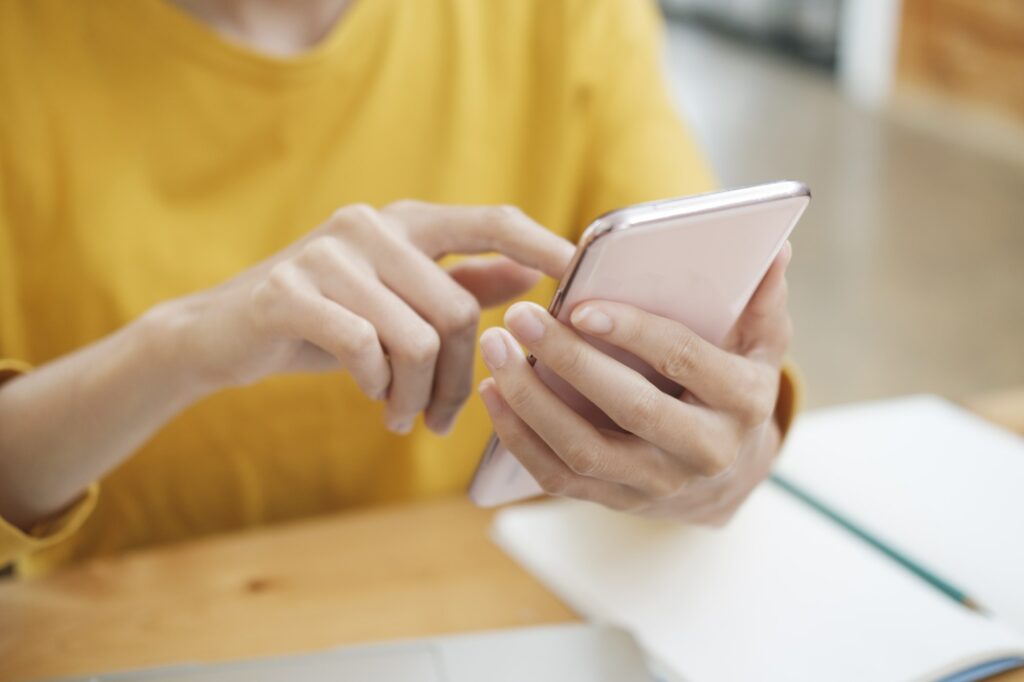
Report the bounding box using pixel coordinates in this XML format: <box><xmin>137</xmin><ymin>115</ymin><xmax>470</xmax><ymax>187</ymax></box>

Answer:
<box><xmin>69</xmin><ymin>624</ymin><xmax>653</xmax><ymax>682</ymax></box>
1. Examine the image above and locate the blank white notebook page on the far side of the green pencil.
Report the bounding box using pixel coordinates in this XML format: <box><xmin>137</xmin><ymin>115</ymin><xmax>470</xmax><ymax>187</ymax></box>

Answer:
<box><xmin>777</xmin><ymin>395</ymin><xmax>1024</xmax><ymax>633</ymax></box>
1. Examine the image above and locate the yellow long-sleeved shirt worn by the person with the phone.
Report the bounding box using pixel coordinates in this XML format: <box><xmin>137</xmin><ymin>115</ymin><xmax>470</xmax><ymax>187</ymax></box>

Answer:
<box><xmin>0</xmin><ymin>0</ymin><xmax>790</xmax><ymax>573</ymax></box>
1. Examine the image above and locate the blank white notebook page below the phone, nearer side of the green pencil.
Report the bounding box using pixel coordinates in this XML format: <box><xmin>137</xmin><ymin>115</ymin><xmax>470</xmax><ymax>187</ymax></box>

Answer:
<box><xmin>495</xmin><ymin>486</ymin><xmax>1024</xmax><ymax>682</ymax></box>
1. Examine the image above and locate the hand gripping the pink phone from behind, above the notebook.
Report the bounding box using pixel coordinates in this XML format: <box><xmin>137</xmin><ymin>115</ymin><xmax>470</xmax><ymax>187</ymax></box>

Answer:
<box><xmin>479</xmin><ymin>243</ymin><xmax>792</xmax><ymax>525</ymax></box>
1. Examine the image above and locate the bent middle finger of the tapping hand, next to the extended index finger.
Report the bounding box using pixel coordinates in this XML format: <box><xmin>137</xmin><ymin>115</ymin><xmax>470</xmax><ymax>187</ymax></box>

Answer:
<box><xmin>377</xmin><ymin>236</ymin><xmax>480</xmax><ymax>434</ymax></box>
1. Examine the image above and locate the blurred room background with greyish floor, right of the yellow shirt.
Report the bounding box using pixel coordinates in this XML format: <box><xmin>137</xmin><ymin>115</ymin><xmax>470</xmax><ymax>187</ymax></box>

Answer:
<box><xmin>663</xmin><ymin>0</ymin><xmax>1024</xmax><ymax>408</ymax></box>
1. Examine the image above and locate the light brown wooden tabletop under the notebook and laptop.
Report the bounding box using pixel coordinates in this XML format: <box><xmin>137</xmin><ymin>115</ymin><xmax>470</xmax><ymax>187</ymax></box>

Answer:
<box><xmin>0</xmin><ymin>392</ymin><xmax>1024</xmax><ymax>682</ymax></box>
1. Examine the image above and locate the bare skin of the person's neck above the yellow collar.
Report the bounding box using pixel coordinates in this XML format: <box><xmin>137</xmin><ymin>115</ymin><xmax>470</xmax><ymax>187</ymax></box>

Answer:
<box><xmin>168</xmin><ymin>0</ymin><xmax>354</xmax><ymax>56</ymax></box>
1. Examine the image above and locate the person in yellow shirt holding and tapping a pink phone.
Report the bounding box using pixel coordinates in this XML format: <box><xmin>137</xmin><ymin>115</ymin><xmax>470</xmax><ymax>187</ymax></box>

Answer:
<box><xmin>0</xmin><ymin>0</ymin><xmax>794</xmax><ymax>573</ymax></box>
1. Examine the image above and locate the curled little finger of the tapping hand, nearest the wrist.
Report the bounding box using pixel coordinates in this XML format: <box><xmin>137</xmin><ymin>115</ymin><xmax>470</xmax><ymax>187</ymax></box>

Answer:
<box><xmin>257</xmin><ymin>261</ymin><xmax>391</xmax><ymax>400</ymax></box>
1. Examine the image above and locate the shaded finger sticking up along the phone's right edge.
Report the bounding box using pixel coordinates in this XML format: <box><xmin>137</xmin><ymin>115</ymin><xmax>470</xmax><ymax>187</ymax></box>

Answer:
<box><xmin>726</xmin><ymin>242</ymin><xmax>793</xmax><ymax>366</ymax></box>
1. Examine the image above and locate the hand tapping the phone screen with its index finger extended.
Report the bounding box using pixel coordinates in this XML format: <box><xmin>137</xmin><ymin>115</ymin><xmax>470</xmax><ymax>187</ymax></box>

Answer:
<box><xmin>162</xmin><ymin>201</ymin><xmax>573</xmax><ymax>433</ymax></box>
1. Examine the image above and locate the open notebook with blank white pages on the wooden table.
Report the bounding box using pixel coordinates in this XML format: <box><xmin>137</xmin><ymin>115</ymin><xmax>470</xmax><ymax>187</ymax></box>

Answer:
<box><xmin>495</xmin><ymin>396</ymin><xmax>1024</xmax><ymax>682</ymax></box>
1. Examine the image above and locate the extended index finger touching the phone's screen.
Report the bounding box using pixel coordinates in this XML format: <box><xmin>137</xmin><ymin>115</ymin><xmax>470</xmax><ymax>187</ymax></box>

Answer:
<box><xmin>385</xmin><ymin>201</ymin><xmax>575</xmax><ymax>278</ymax></box>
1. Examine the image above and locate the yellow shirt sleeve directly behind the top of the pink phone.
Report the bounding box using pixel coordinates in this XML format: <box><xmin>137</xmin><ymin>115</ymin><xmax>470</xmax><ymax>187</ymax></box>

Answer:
<box><xmin>575</xmin><ymin>0</ymin><xmax>716</xmax><ymax>227</ymax></box>
